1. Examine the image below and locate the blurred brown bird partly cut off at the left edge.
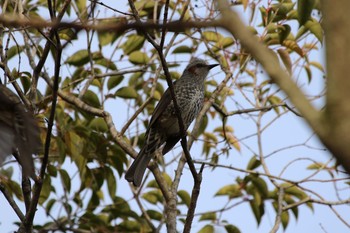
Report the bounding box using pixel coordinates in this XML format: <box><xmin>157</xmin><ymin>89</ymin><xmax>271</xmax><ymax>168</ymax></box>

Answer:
<box><xmin>0</xmin><ymin>84</ymin><xmax>41</xmax><ymax>177</ymax></box>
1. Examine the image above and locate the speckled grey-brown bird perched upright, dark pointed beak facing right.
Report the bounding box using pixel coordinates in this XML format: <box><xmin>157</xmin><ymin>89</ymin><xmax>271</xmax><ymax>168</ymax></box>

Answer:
<box><xmin>125</xmin><ymin>58</ymin><xmax>219</xmax><ymax>187</ymax></box>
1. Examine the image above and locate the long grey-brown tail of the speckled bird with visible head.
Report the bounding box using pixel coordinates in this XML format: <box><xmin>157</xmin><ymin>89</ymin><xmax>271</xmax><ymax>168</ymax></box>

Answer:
<box><xmin>125</xmin><ymin>130</ymin><xmax>162</xmax><ymax>187</ymax></box>
